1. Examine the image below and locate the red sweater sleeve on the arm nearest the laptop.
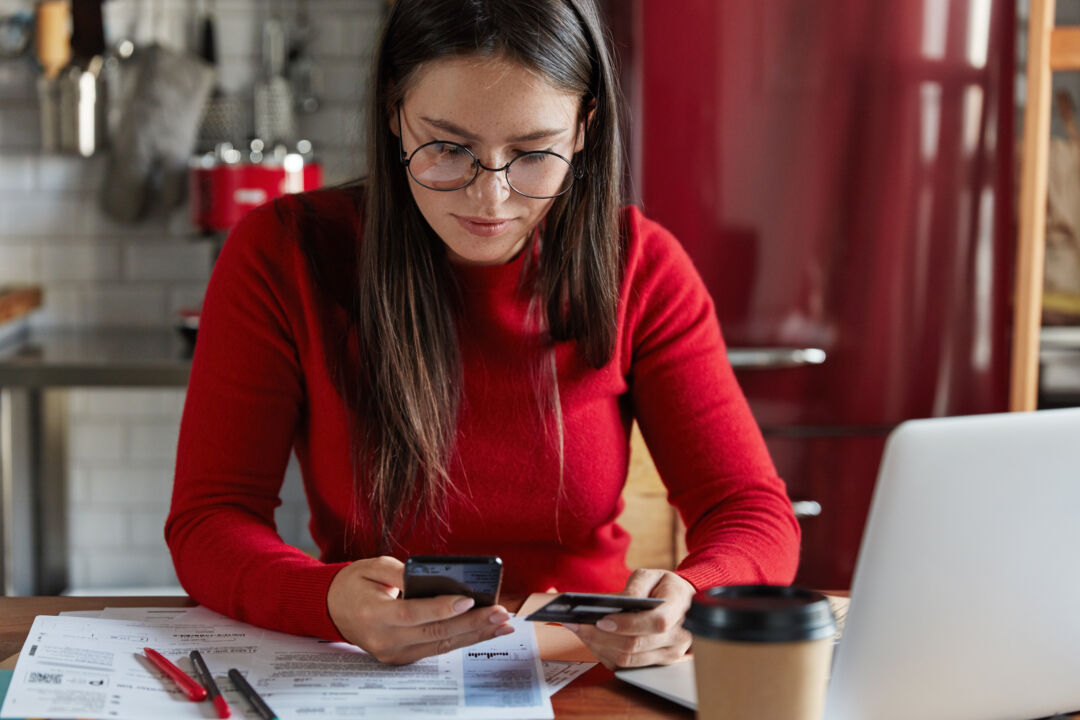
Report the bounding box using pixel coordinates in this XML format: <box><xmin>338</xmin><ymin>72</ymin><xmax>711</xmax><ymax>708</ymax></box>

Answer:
<box><xmin>624</xmin><ymin>208</ymin><xmax>799</xmax><ymax>588</ymax></box>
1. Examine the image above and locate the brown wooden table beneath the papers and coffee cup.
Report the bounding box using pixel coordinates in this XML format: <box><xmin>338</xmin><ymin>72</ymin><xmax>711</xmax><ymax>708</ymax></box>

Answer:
<box><xmin>0</xmin><ymin>597</ymin><xmax>693</xmax><ymax>720</ymax></box>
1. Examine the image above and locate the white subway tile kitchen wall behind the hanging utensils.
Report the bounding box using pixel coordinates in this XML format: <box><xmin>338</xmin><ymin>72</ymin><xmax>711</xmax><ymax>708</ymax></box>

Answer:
<box><xmin>0</xmin><ymin>0</ymin><xmax>386</xmax><ymax>592</ymax></box>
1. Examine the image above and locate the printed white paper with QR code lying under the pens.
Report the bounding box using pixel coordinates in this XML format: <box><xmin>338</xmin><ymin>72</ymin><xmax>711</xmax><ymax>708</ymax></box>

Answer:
<box><xmin>0</xmin><ymin>608</ymin><xmax>552</xmax><ymax>720</ymax></box>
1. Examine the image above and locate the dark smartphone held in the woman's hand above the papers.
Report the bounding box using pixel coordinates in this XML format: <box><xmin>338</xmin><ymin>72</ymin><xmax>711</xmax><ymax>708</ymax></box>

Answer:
<box><xmin>402</xmin><ymin>555</ymin><xmax>502</xmax><ymax>608</ymax></box>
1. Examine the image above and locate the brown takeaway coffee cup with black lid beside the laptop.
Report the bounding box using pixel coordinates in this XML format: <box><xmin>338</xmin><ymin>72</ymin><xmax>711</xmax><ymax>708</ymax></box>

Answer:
<box><xmin>683</xmin><ymin>585</ymin><xmax>836</xmax><ymax>720</ymax></box>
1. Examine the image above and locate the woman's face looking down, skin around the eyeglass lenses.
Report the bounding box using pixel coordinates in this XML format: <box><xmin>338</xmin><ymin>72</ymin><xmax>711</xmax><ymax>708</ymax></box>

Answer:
<box><xmin>390</xmin><ymin>57</ymin><xmax>584</xmax><ymax>264</ymax></box>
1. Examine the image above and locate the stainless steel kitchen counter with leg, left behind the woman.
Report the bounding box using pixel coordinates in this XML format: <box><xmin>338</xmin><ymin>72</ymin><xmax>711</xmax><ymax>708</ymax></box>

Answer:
<box><xmin>0</xmin><ymin>328</ymin><xmax>191</xmax><ymax>595</ymax></box>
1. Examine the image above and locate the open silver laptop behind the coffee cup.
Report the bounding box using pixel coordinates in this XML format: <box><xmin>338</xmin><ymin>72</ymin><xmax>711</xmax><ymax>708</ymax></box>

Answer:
<box><xmin>617</xmin><ymin>409</ymin><xmax>1080</xmax><ymax>720</ymax></box>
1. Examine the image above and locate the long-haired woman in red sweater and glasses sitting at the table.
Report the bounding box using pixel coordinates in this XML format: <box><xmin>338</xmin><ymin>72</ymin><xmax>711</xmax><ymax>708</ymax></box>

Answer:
<box><xmin>165</xmin><ymin>0</ymin><xmax>798</xmax><ymax>666</ymax></box>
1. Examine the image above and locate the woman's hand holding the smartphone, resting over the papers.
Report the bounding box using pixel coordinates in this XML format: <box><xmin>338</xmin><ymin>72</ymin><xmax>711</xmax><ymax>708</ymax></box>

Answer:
<box><xmin>326</xmin><ymin>557</ymin><xmax>514</xmax><ymax>665</ymax></box>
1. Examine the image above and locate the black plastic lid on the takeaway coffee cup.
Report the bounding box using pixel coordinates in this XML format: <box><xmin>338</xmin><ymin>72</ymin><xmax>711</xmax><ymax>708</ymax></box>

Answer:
<box><xmin>683</xmin><ymin>585</ymin><xmax>836</xmax><ymax>642</ymax></box>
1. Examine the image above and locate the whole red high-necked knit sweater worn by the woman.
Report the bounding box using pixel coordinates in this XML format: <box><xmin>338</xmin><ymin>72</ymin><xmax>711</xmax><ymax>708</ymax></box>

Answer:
<box><xmin>165</xmin><ymin>191</ymin><xmax>799</xmax><ymax>640</ymax></box>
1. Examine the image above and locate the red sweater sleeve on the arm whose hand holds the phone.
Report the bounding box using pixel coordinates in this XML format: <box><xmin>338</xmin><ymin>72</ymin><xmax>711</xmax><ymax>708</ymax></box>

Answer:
<box><xmin>165</xmin><ymin>205</ymin><xmax>345</xmax><ymax>640</ymax></box>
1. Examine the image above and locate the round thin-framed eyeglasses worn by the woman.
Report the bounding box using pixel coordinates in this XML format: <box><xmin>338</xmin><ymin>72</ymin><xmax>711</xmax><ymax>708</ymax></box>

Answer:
<box><xmin>397</xmin><ymin>106</ymin><xmax>585</xmax><ymax>200</ymax></box>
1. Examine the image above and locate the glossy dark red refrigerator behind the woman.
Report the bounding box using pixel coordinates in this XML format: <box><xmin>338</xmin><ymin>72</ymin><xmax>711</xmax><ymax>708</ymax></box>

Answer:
<box><xmin>608</xmin><ymin>0</ymin><xmax>1016</xmax><ymax>588</ymax></box>
